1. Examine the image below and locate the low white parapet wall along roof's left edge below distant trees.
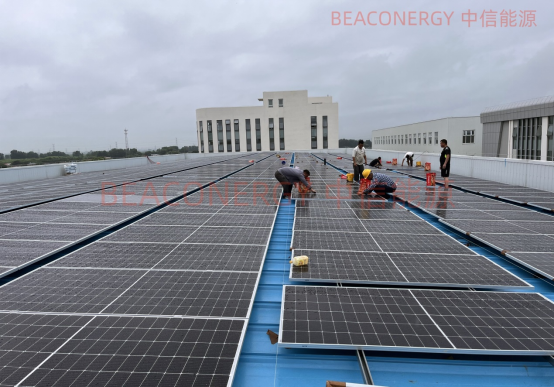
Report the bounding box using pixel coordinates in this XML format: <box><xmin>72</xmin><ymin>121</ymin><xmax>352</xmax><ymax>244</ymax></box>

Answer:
<box><xmin>0</xmin><ymin>153</ymin><xmax>210</xmax><ymax>184</ymax></box>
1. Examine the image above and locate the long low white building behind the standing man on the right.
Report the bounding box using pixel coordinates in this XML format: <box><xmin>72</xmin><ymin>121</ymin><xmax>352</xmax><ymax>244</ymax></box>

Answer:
<box><xmin>372</xmin><ymin>116</ymin><xmax>483</xmax><ymax>156</ymax></box>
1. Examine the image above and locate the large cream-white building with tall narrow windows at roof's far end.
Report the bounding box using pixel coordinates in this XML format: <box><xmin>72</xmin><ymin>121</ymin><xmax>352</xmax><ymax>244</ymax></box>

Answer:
<box><xmin>196</xmin><ymin>90</ymin><xmax>339</xmax><ymax>153</ymax></box>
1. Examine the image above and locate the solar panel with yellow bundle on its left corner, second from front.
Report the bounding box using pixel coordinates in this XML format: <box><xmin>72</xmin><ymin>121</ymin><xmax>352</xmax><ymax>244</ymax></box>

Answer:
<box><xmin>290</xmin><ymin>250</ymin><xmax>530</xmax><ymax>289</ymax></box>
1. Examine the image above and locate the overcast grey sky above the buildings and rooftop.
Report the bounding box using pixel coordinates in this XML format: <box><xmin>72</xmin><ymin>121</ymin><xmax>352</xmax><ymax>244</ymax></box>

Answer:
<box><xmin>0</xmin><ymin>0</ymin><xmax>554</xmax><ymax>153</ymax></box>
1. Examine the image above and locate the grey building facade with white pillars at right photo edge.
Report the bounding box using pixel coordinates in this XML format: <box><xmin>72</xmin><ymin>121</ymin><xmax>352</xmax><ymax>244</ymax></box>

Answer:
<box><xmin>481</xmin><ymin>96</ymin><xmax>554</xmax><ymax>161</ymax></box>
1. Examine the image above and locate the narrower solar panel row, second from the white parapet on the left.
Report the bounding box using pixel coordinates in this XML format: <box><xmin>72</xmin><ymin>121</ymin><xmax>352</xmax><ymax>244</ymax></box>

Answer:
<box><xmin>0</xmin><ymin>156</ymin><xmax>261</xmax><ymax>277</ymax></box>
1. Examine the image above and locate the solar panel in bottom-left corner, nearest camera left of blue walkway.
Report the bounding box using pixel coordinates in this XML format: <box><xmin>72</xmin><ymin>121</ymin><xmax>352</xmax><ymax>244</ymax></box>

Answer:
<box><xmin>0</xmin><ymin>314</ymin><xmax>246</xmax><ymax>386</ymax></box>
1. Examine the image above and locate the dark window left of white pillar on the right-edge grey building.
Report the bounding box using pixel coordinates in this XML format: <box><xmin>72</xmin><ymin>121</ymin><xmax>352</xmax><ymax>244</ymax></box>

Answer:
<box><xmin>514</xmin><ymin>117</ymin><xmax>548</xmax><ymax>160</ymax></box>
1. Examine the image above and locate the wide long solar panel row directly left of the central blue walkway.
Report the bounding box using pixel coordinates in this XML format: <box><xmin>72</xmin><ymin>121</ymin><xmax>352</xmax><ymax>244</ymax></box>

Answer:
<box><xmin>0</xmin><ymin>154</ymin><xmax>286</xmax><ymax>386</ymax></box>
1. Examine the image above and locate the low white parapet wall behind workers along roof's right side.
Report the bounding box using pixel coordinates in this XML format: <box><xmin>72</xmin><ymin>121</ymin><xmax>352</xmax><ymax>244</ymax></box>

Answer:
<box><xmin>358</xmin><ymin>149</ymin><xmax>554</xmax><ymax>192</ymax></box>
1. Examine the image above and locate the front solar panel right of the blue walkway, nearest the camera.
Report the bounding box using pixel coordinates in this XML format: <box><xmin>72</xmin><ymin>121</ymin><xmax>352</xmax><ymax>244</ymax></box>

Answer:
<box><xmin>279</xmin><ymin>286</ymin><xmax>554</xmax><ymax>355</ymax></box>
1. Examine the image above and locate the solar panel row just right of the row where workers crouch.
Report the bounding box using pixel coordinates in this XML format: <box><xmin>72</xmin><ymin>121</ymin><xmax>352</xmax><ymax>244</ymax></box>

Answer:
<box><xmin>386</xmin><ymin>171</ymin><xmax>554</xmax><ymax>279</ymax></box>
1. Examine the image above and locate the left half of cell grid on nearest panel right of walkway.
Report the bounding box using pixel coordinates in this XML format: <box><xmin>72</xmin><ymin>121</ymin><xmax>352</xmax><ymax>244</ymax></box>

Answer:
<box><xmin>279</xmin><ymin>286</ymin><xmax>452</xmax><ymax>349</ymax></box>
